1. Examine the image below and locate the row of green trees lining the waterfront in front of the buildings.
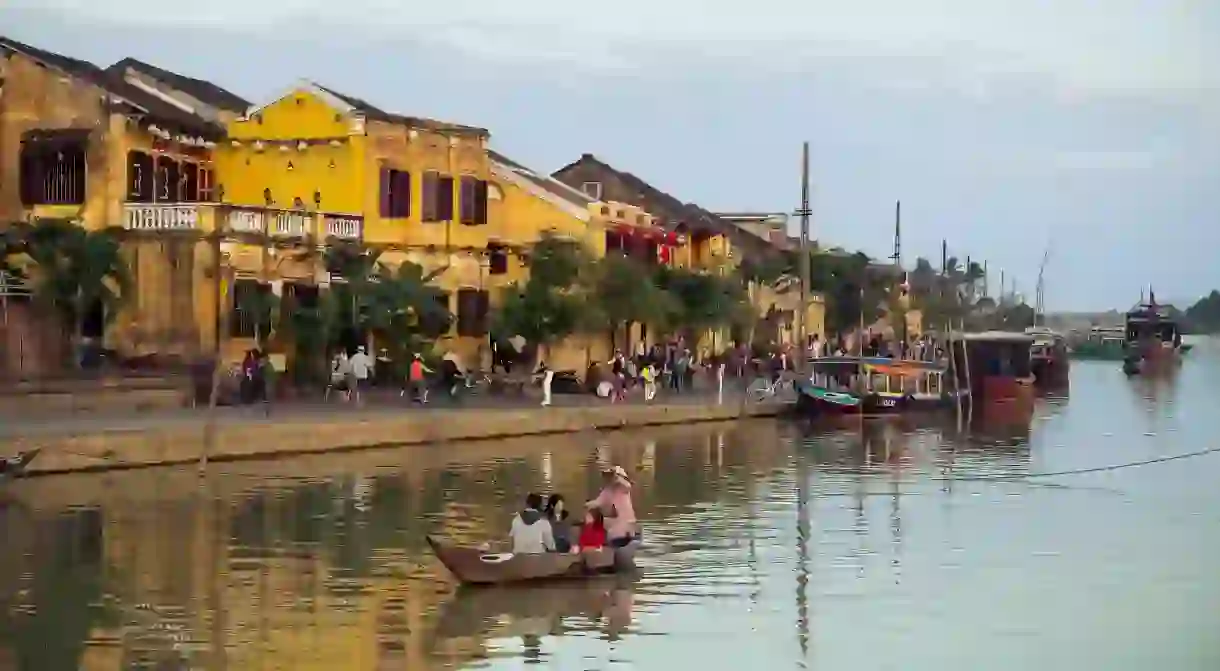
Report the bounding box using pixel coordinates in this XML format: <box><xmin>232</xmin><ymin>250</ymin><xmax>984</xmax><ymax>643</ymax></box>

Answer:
<box><xmin>0</xmin><ymin>220</ymin><xmax>1033</xmax><ymax>384</ymax></box>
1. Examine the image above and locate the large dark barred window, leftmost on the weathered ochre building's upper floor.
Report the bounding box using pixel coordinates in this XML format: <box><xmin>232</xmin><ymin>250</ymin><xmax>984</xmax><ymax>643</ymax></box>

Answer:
<box><xmin>18</xmin><ymin>138</ymin><xmax>87</xmax><ymax>205</ymax></box>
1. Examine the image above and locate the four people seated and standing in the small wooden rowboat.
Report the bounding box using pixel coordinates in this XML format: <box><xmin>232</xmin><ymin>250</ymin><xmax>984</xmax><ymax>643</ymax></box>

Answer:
<box><xmin>509</xmin><ymin>466</ymin><xmax>638</xmax><ymax>554</ymax></box>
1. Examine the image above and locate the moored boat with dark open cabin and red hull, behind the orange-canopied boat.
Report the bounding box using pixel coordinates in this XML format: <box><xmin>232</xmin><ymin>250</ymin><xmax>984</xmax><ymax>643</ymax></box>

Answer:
<box><xmin>952</xmin><ymin>331</ymin><xmax>1035</xmax><ymax>403</ymax></box>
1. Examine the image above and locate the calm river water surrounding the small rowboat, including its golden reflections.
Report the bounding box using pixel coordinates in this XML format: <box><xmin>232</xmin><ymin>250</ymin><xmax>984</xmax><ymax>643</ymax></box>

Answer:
<box><xmin>0</xmin><ymin>348</ymin><xmax>1220</xmax><ymax>671</ymax></box>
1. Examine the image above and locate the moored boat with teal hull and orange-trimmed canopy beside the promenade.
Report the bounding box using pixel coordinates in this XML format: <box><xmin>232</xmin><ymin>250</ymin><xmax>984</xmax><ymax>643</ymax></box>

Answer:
<box><xmin>794</xmin><ymin>356</ymin><xmax>965</xmax><ymax>416</ymax></box>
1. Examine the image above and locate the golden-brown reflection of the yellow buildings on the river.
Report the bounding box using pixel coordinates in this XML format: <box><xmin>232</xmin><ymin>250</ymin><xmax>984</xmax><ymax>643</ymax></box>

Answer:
<box><xmin>0</xmin><ymin>422</ymin><xmax>788</xmax><ymax>671</ymax></box>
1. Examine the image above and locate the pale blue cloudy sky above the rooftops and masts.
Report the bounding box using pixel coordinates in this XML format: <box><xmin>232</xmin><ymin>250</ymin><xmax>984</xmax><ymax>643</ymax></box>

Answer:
<box><xmin>0</xmin><ymin>0</ymin><xmax>1220</xmax><ymax>310</ymax></box>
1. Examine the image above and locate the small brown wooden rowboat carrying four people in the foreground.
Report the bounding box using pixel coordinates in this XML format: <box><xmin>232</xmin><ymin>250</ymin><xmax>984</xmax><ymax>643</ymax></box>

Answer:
<box><xmin>427</xmin><ymin>536</ymin><xmax>639</xmax><ymax>584</ymax></box>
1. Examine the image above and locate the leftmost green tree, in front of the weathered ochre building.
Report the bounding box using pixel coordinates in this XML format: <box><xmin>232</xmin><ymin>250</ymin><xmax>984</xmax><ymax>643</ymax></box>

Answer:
<box><xmin>5</xmin><ymin>220</ymin><xmax>133</xmax><ymax>363</ymax></box>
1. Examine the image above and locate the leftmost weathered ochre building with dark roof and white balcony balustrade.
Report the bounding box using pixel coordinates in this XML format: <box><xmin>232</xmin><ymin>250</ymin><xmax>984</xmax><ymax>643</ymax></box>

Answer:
<box><xmin>0</xmin><ymin>39</ymin><xmax>235</xmax><ymax>373</ymax></box>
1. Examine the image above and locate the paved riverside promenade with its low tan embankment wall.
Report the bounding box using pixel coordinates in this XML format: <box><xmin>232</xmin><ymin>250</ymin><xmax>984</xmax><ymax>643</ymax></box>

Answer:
<box><xmin>0</xmin><ymin>390</ymin><xmax>783</xmax><ymax>473</ymax></box>
